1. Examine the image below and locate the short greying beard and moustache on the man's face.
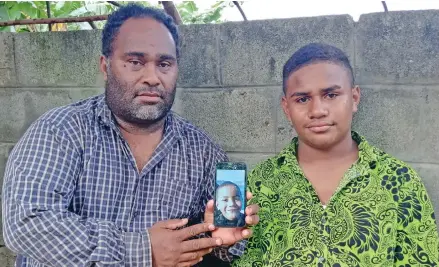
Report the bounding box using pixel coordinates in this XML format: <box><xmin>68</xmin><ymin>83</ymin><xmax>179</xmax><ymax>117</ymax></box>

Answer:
<box><xmin>105</xmin><ymin>68</ymin><xmax>176</xmax><ymax>126</ymax></box>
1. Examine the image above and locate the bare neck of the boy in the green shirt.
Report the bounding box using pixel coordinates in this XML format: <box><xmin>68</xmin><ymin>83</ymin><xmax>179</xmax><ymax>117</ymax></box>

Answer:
<box><xmin>297</xmin><ymin>132</ymin><xmax>358</xmax><ymax>162</ymax></box>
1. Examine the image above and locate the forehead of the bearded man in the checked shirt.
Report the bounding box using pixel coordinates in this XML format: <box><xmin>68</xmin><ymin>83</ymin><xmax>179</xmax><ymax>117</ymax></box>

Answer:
<box><xmin>113</xmin><ymin>18</ymin><xmax>176</xmax><ymax>56</ymax></box>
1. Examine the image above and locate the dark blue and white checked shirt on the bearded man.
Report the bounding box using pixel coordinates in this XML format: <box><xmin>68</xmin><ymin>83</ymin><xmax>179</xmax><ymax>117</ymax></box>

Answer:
<box><xmin>3</xmin><ymin>95</ymin><xmax>245</xmax><ymax>266</ymax></box>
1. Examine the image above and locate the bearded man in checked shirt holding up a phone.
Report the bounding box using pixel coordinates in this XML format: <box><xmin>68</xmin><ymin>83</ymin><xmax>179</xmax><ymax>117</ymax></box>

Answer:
<box><xmin>3</xmin><ymin>5</ymin><xmax>258</xmax><ymax>267</ymax></box>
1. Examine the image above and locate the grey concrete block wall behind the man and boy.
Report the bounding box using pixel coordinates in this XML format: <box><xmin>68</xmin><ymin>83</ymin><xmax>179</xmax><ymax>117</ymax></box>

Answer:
<box><xmin>0</xmin><ymin>11</ymin><xmax>439</xmax><ymax>267</ymax></box>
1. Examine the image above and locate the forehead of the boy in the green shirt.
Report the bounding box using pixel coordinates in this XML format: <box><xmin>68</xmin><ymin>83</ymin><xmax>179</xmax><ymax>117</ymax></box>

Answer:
<box><xmin>287</xmin><ymin>62</ymin><xmax>351</xmax><ymax>90</ymax></box>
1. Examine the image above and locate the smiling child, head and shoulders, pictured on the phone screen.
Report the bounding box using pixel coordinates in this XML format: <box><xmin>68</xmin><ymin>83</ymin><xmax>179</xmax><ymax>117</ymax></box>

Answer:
<box><xmin>215</xmin><ymin>182</ymin><xmax>245</xmax><ymax>227</ymax></box>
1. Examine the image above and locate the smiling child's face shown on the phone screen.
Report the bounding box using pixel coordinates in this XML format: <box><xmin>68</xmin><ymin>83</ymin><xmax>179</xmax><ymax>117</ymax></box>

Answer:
<box><xmin>216</xmin><ymin>185</ymin><xmax>242</xmax><ymax>221</ymax></box>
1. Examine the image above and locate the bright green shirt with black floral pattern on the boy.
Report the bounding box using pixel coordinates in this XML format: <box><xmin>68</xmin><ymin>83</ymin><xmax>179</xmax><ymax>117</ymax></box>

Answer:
<box><xmin>233</xmin><ymin>132</ymin><xmax>439</xmax><ymax>267</ymax></box>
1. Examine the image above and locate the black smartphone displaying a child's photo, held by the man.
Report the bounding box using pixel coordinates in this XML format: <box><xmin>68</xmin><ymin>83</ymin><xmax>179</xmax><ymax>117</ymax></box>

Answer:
<box><xmin>213</xmin><ymin>162</ymin><xmax>247</xmax><ymax>228</ymax></box>
